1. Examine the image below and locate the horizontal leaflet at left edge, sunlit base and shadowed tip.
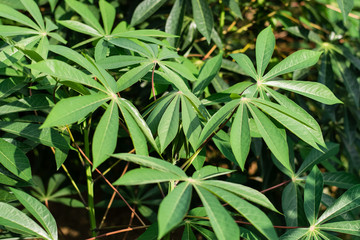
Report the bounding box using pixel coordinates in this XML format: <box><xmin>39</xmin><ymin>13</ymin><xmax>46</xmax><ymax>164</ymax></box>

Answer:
<box><xmin>0</xmin><ymin>94</ymin><xmax>54</xmax><ymax>115</ymax></box>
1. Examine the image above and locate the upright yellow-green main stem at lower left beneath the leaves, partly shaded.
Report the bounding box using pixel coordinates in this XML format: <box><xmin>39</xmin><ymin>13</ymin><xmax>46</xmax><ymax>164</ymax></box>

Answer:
<box><xmin>84</xmin><ymin>123</ymin><xmax>96</xmax><ymax>237</ymax></box>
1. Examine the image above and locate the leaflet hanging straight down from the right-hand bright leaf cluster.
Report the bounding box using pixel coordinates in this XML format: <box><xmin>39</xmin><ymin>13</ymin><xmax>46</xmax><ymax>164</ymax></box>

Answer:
<box><xmin>230</xmin><ymin>102</ymin><xmax>251</xmax><ymax>171</ymax></box>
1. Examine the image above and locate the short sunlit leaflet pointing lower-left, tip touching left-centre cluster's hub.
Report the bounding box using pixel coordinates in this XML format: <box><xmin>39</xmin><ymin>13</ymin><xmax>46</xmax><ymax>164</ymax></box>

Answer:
<box><xmin>116</xmin><ymin>62</ymin><xmax>154</xmax><ymax>92</ymax></box>
